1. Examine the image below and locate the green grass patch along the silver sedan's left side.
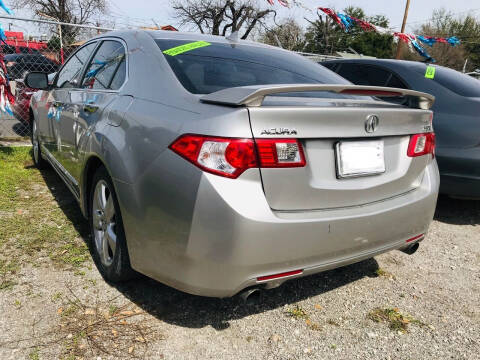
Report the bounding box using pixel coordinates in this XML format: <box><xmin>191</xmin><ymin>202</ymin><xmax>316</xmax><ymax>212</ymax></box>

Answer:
<box><xmin>0</xmin><ymin>147</ymin><xmax>91</xmax><ymax>289</ymax></box>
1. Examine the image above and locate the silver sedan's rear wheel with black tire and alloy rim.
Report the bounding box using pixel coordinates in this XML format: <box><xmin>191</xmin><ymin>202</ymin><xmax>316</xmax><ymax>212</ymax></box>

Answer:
<box><xmin>89</xmin><ymin>166</ymin><xmax>137</xmax><ymax>282</ymax></box>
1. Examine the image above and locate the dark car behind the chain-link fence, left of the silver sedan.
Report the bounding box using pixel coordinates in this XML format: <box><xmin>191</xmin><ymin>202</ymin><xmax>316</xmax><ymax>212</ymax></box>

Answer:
<box><xmin>4</xmin><ymin>54</ymin><xmax>59</xmax><ymax>80</ymax></box>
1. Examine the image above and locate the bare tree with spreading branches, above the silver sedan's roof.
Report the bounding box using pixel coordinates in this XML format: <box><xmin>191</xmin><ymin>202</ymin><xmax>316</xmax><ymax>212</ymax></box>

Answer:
<box><xmin>171</xmin><ymin>0</ymin><xmax>277</xmax><ymax>39</ymax></box>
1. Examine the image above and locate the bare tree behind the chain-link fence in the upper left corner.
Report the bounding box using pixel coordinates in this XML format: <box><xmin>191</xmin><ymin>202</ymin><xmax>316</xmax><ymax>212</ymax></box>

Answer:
<box><xmin>13</xmin><ymin>0</ymin><xmax>108</xmax><ymax>41</ymax></box>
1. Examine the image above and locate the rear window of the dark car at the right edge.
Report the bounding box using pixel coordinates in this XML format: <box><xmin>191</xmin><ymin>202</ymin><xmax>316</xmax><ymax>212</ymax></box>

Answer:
<box><xmin>428</xmin><ymin>67</ymin><xmax>480</xmax><ymax>97</ymax></box>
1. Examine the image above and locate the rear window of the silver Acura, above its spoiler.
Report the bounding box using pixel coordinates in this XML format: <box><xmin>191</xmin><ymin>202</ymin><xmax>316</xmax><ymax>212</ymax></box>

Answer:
<box><xmin>155</xmin><ymin>39</ymin><xmax>350</xmax><ymax>98</ymax></box>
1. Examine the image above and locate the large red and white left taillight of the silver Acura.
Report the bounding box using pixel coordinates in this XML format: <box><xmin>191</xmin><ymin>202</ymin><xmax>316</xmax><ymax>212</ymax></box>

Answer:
<box><xmin>169</xmin><ymin>134</ymin><xmax>306</xmax><ymax>179</ymax></box>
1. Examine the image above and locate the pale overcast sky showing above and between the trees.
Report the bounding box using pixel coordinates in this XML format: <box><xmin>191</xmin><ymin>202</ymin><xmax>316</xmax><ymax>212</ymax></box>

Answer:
<box><xmin>111</xmin><ymin>0</ymin><xmax>480</xmax><ymax>31</ymax></box>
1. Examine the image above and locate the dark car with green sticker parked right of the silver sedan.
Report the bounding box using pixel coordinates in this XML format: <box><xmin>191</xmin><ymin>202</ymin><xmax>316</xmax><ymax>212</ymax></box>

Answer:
<box><xmin>321</xmin><ymin>59</ymin><xmax>480</xmax><ymax>199</ymax></box>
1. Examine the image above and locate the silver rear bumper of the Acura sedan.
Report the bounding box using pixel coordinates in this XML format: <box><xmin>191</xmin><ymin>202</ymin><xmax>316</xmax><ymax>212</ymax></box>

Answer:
<box><xmin>134</xmin><ymin>161</ymin><xmax>439</xmax><ymax>297</ymax></box>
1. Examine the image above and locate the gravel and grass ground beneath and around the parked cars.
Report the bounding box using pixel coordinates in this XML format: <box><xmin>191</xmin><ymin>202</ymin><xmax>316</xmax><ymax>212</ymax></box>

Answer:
<box><xmin>0</xmin><ymin>147</ymin><xmax>480</xmax><ymax>360</ymax></box>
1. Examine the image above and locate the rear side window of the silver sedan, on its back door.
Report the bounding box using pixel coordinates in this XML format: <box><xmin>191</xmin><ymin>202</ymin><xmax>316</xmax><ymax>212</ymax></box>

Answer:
<box><xmin>82</xmin><ymin>40</ymin><xmax>126</xmax><ymax>90</ymax></box>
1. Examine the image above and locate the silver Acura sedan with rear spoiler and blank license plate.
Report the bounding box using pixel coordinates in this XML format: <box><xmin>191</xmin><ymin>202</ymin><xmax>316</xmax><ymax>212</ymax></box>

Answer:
<box><xmin>26</xmin><ymin>30</ymin><xmax>439</xmax><ymax>297</ymax></box>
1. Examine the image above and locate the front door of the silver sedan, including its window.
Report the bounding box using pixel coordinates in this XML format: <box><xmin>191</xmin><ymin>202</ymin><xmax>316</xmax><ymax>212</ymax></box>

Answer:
<box><xmin>45</xmin><ymin>42</ymin><xmax>97</xmax><ymax>185</ymax></box>
